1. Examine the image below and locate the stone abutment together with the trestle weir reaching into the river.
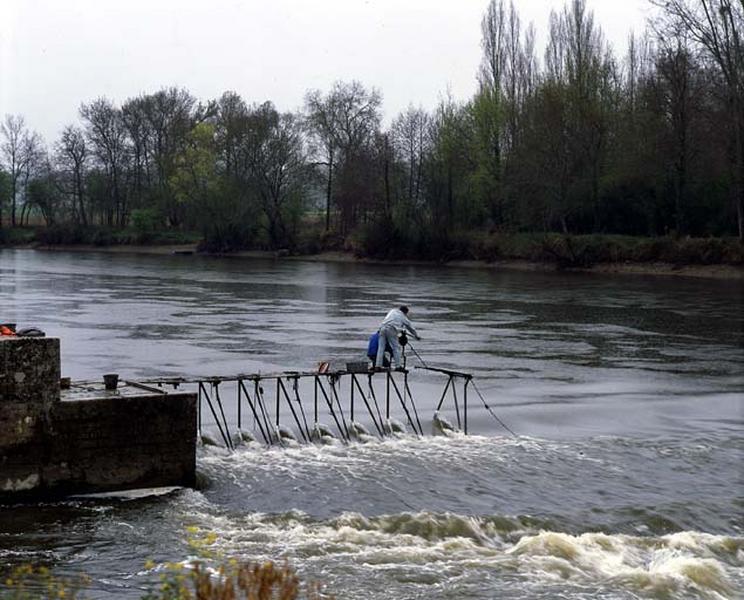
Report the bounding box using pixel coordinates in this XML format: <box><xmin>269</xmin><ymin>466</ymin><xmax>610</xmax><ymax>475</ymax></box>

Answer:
<box><xmin>0</xmin><ymin>337</ymin><xmax>508</xmax><ymax>501</ymax></box>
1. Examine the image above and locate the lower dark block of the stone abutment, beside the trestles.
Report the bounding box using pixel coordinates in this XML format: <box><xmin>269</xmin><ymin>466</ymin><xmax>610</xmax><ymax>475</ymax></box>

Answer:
<box><xmin>42</xmin><ymin>393</ymin><xmax>197</xmax><ymax>495</ymax></box>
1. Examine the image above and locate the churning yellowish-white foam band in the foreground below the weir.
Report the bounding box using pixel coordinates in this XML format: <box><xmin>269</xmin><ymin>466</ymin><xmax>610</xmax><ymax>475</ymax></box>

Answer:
<box><xmin>177</xmin><ymin>502</ymin><xmax>744</xmax><ymax>600</ymax></box>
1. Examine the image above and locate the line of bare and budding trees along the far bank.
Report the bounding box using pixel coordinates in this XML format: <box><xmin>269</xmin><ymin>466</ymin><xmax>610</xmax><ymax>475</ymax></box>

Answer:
<box><xmin>0</xmin><ymin>0</ymin><xmax>744</xmax><ymax>258</ymax></box>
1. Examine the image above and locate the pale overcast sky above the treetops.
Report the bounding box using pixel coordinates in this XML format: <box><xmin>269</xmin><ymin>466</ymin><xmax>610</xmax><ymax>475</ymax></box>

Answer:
<box><xmin>0</xmin><ymin>0</ymin><xmax>650</xmax><ymax>143</ymax></box>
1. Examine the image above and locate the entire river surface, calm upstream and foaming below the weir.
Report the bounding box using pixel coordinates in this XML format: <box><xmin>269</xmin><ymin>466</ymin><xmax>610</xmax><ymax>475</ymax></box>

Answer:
<box><xmin>0</xmin><ymin>250</ymin><xmax>744</xmax><ymax>599</ymax></box>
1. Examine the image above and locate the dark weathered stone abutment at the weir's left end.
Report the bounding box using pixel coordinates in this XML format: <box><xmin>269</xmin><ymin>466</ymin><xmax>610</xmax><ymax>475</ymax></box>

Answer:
<box><xmin>0</xmin><ymin>337</ymin><xmax>197</xmax><ymax>501</ymax></box>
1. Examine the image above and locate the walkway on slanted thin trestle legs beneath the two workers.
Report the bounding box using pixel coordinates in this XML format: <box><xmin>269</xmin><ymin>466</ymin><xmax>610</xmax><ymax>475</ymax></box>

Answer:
<box><xmin>138</xmin><ymin>366</ymin><xmax>473</xmax><ymax>449</ymax></box>
